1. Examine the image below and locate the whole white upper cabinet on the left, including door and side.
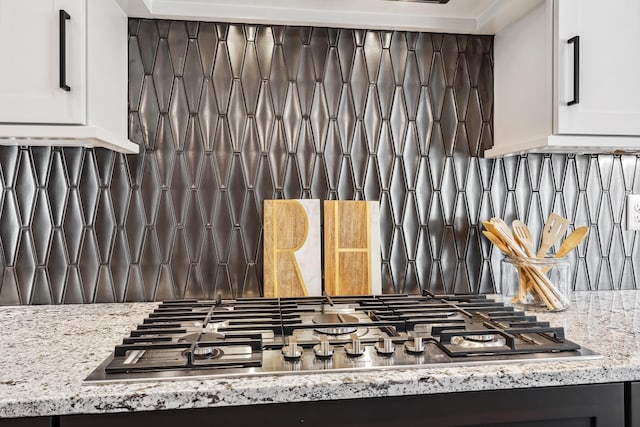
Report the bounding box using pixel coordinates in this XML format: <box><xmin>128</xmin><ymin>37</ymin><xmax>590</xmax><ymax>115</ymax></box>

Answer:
<box><xmin>0</xmin><ymin>0</ymin><xmax>139</xmax><ymax>153</ymax></box>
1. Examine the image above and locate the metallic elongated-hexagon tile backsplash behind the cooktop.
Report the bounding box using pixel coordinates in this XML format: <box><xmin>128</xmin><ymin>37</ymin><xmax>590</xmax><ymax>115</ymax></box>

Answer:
<box><xmin>0</xmin><ymin>19</ymin><xmax>640</xmax><ymax>304</ymax></box>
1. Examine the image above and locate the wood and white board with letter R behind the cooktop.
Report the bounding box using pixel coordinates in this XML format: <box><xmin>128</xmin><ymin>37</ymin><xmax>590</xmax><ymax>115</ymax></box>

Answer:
<box><xmin>263</xmin><ymin>200</ymin><xmax>322</xmax><ymax>297</ymax></box>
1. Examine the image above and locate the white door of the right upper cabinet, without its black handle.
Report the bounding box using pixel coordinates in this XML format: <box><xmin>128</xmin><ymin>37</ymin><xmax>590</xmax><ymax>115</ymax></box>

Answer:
<box><xmin>554</xmin><ymin>0</ymin><xmax>640</xmax><ymax>135</ymax></box>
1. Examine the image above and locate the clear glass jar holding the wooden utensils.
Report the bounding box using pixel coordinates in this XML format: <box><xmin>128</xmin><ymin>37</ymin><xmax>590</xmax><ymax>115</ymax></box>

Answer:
<box><xmin>500</xmin><ymin>257</ymin><xmax>571</xmax><ymax>311</ymax></box>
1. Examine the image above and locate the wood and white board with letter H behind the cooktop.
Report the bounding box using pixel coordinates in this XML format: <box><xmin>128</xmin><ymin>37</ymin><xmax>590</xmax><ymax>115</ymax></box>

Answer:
<box><xmin>324</xmin><ymin>200</ymin><xmax>382</xmax><ymax>295</ymax></box>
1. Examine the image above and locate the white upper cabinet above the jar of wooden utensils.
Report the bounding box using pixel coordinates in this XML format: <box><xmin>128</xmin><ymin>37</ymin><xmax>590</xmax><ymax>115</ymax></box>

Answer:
<box><xmin>492</xmin><ymin>0</ymin><xmax>640</xmax><ymax>157</ymax></box>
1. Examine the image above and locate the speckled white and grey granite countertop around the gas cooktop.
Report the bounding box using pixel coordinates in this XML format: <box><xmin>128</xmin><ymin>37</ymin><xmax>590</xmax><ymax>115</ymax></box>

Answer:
<box><xmin>0</xmin><ymin>291</ymin><xmax>640</xmax><ymax>417</ymax></box>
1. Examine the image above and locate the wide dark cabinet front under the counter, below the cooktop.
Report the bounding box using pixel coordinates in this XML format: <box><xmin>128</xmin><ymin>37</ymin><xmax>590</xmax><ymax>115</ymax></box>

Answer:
<box><xmin>57</xmin><ymin>383</ymin><xmax>624</xmax><ymax>427</ymax></box>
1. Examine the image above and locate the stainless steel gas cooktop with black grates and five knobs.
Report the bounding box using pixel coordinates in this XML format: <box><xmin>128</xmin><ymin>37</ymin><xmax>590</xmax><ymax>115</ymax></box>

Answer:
<box><xmin>86</xmin><ymin>293</ymin><xmax>600</xmax><ymax>383</ymax></box>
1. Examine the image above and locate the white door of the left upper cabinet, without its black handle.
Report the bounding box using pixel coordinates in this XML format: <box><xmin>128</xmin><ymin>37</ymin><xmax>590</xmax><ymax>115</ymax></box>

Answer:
<box><xmin>0</xmin><ymin>0</ymin><xmax>86</xmax><ymax>124</ymax></box>
